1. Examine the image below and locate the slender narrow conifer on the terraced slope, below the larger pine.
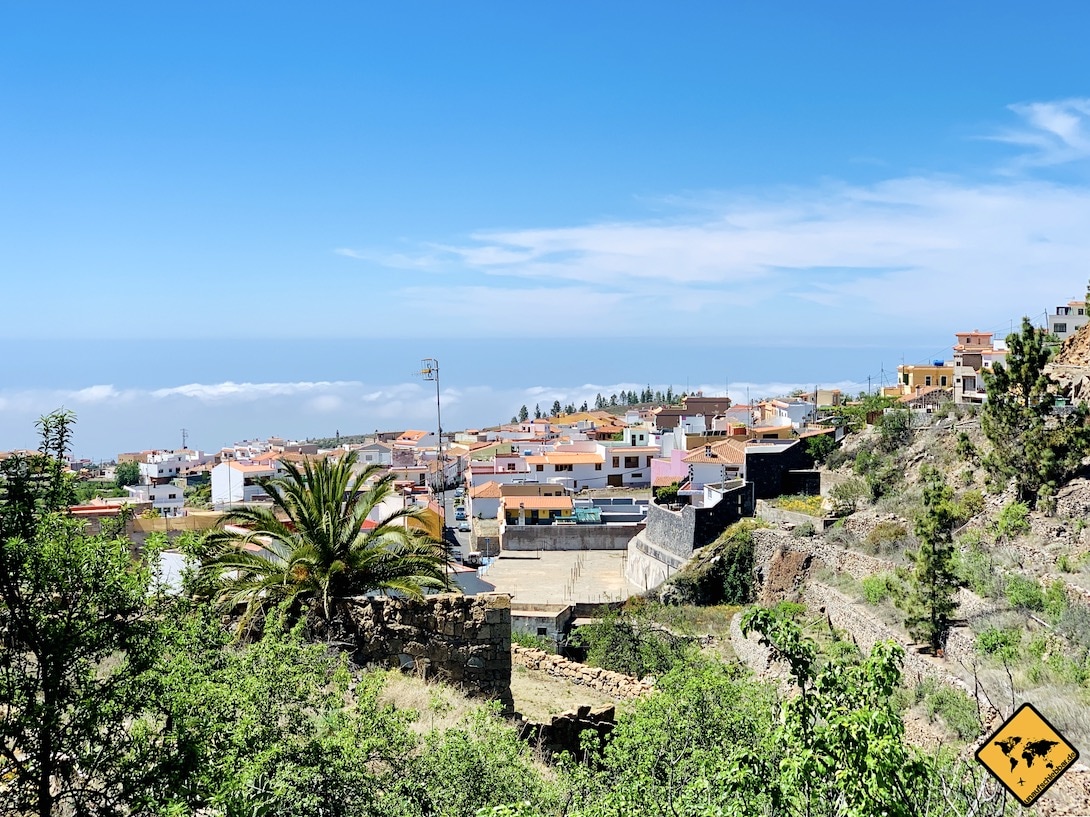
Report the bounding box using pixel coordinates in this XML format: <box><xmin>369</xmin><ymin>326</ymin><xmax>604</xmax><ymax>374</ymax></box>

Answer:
<box><xmin>901</xmin><ymin>466</ymin><xmax>959</xmax><ymax>650</ymax></box>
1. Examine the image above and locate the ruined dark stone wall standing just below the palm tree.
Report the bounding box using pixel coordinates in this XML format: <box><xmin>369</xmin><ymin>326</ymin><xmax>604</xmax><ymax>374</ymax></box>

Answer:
<box><xmin>315</xmin><ymin>593</ymin><xmax>513</xmax><ymax>709</ymax></box>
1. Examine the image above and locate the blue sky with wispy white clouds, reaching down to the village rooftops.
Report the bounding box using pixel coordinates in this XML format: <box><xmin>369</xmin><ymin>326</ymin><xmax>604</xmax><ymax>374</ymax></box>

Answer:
<box><xmin>0</xmin><ymin>2</ymin><xmax>1090</xmax><ymax>452</ymax></box>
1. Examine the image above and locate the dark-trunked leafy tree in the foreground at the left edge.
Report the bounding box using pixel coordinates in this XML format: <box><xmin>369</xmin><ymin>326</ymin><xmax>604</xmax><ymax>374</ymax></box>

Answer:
<box><xmin>0</xmin><ymin>412</ymin><xmax>157</xmax><ymax>816</ymax></box>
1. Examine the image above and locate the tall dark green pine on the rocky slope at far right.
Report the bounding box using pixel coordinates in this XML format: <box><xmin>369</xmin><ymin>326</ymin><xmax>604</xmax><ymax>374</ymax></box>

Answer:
<box><xmin>981</xmin><ymin>318</ymin><xmax>1090</xmax><ymax>507</ymax></box>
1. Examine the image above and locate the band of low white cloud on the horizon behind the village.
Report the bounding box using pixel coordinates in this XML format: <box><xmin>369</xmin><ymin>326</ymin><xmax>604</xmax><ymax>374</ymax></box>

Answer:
<box><xmin>0</xmin><ymin>381</ymin><xmax>865</xmax><ymax>459</ymax></box>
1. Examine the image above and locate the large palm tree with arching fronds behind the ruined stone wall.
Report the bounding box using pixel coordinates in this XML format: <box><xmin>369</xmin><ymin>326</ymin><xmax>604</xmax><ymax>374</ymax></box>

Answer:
<box><xmin>201</xmin><ymin>451</ymin><xmax>449</xmax><ymax>622</ymax></box>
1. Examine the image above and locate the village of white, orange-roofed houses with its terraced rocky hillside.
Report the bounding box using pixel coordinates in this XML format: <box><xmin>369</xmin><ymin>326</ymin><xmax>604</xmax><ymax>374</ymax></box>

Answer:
<box><xmin>6</xmin><ymin>303</ymin><xmax>1090</xmax><ymax>815</ymax></box>
